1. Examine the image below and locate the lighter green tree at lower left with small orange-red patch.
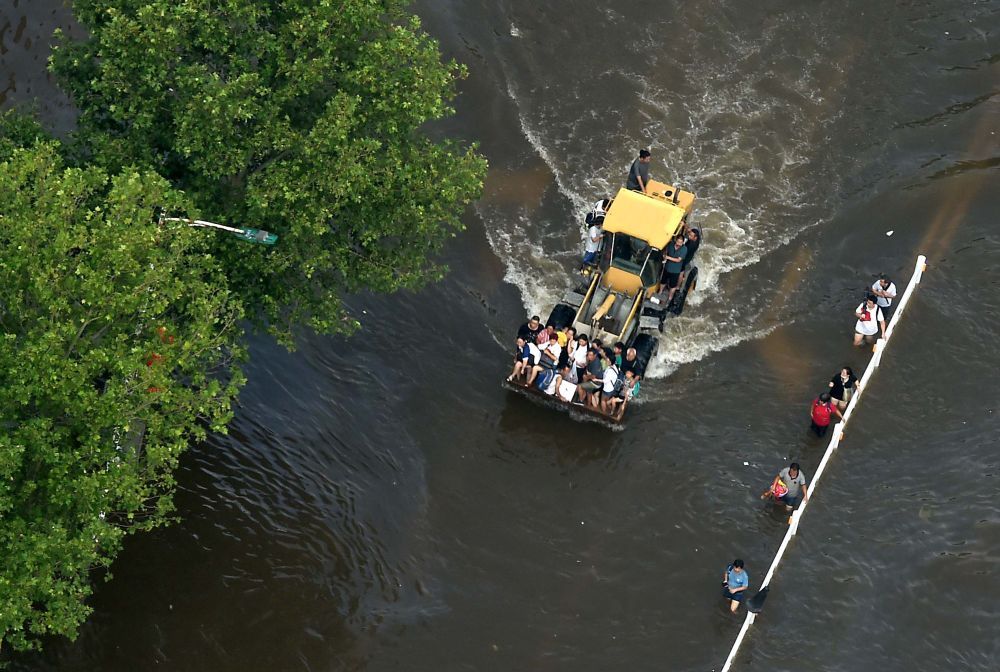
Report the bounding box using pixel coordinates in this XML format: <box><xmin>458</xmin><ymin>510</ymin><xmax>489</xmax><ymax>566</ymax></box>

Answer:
<box><xmin>0</xmin><ymin>142</ymin><xmax>246</xmax><ymax>649</ymax></box>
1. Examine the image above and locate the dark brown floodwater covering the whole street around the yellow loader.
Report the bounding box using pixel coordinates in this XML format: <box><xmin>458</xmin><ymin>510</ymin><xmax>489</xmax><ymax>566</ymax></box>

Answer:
<box><xmin>0</xmin><ymin>0</ymin><xmax>1000</xmax><ymax>672</ymax></box>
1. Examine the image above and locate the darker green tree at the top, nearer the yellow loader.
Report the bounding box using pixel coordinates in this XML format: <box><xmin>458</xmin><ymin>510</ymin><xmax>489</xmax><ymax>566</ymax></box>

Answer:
<box><xmin>51</xmin><ymin>0</ymin><xmax>485</xmax><ymax>344</ymax></box>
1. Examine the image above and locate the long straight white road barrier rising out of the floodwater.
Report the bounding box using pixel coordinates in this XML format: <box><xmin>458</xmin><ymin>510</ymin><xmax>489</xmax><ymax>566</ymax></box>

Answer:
<box><xmin>721</xmin><ymin>255</ymin><xmax>927</xmax><ymax>672</ymax></box>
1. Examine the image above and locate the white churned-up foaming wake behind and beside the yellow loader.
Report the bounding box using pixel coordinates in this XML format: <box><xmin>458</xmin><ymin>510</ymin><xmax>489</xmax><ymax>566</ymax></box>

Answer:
<box><xmin>477</xmin><ymin>22</ymin><xmax>833</xmax><ymax>377</ymax></box>
